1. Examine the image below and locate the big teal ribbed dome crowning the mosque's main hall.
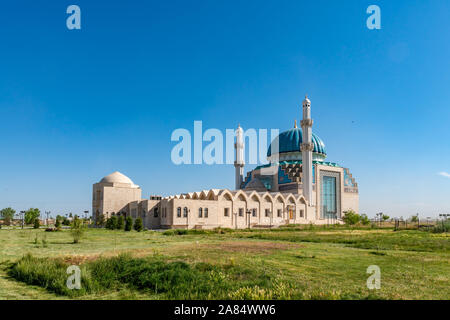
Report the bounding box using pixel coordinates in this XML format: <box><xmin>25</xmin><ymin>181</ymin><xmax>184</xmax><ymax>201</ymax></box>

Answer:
<box><xmin>267</xmin><ymin>128</ymin><xmax>327</xmax><ymax>157</ymax></box>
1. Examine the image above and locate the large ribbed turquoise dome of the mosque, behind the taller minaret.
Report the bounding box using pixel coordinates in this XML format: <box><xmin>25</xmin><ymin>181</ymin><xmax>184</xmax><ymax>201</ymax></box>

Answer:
<box><xmin>267</xmin><ymin>127</ymin><xmax>327</xmax><ymax>161</ymax></box>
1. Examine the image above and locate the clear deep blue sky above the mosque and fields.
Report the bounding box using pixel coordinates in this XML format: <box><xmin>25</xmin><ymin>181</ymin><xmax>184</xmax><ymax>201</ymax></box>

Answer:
<box><xmin>0</xmin><ymin>0</ymin><xmax>450</xmax><ymax>217</ymax></box>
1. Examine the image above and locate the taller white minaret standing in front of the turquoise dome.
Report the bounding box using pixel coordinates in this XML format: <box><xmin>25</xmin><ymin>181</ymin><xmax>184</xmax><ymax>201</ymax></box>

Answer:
<box><xmin>300</xmin><ymin>96</ymin><xmax>314</xmax><ymax>206</ymax></box>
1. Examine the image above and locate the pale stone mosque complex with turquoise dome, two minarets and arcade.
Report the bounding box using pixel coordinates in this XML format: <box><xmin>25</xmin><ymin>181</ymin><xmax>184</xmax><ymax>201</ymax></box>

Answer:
<box><xmin>92</xmin><ymin>97</ymin><xmax>359</xmax><ymax>229</ymax></box>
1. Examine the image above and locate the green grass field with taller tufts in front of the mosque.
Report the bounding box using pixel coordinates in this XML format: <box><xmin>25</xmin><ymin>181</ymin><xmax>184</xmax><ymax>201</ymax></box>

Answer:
<box><xmin>0</xmin><ymin>227</ymin><xmax>450</xmax><ymax>299</ymax></box>
